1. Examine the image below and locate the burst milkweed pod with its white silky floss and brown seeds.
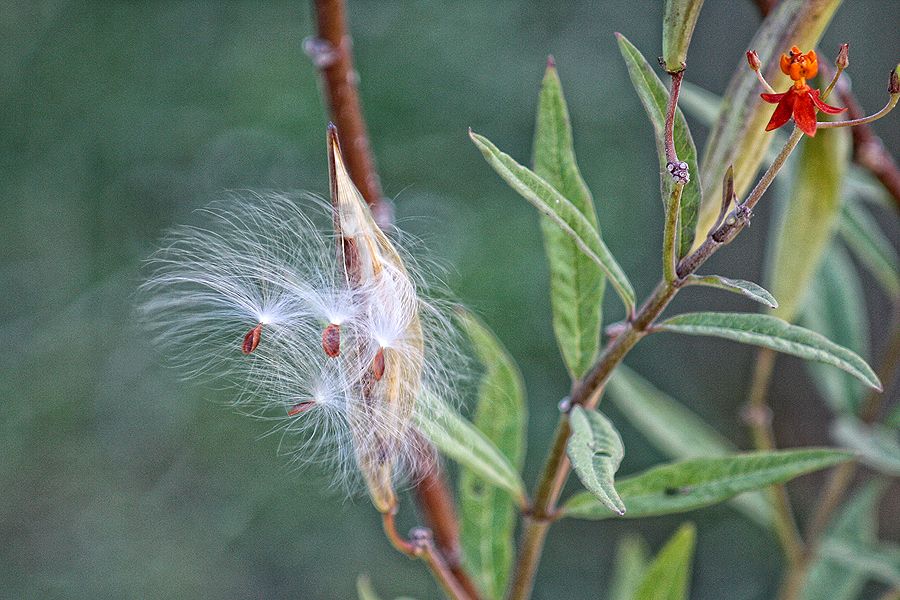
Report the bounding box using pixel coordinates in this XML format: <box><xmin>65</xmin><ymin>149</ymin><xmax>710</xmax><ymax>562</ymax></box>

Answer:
<box><xmin>140</xmin><ymin>124</ymin><xmax>466</xmax><ymax>512</ymax></box>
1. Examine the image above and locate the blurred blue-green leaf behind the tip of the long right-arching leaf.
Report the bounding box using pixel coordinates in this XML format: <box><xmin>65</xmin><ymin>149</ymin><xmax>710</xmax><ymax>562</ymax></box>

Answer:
<box><xmin>801</xmin><ymin>242</ymin><xmax>869</xmax><ymax>414</ymax></box>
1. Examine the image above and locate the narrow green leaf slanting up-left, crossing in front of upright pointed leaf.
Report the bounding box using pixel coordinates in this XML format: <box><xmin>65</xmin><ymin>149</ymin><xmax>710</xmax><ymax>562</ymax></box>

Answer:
<box><xmin>469</xmin><ymin>131</ymin><xmax>634</xmax><ymax>314</ymax></box>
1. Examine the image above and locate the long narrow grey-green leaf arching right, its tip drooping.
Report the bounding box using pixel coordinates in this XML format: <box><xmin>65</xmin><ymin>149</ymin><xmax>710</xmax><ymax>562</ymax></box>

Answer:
<box><xmin>659</xmin><ymin>312</ymin><xmax>881</xmax><ymax>390</ymax></box>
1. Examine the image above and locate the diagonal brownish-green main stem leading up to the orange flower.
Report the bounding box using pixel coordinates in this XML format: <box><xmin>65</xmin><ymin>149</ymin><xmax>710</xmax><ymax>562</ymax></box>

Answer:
<box><xmin>507</xmin><ymin>123</ymin><xmax>803</xmax><ymax>600</ymax></box>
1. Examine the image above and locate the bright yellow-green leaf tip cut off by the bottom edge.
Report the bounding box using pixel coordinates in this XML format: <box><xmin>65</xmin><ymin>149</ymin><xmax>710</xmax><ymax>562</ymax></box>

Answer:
<box><xmin>634</xmin><ymin>523</ymin><xmax>697</xmax><ymax>600</ymax></box>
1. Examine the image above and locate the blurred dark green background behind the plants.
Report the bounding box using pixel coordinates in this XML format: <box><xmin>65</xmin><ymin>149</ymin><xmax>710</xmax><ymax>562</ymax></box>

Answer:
<box><xmin>0</xmin><ymin>0</ymin><xmax>900</xmax><ymax>600</ymax></box>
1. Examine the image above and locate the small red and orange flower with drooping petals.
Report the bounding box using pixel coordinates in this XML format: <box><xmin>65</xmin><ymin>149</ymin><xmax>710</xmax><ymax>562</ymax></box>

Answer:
<box><xmin>760</xmin><ymin>46</ymin><xmax>847</xmax><ymax>136</ymax></box>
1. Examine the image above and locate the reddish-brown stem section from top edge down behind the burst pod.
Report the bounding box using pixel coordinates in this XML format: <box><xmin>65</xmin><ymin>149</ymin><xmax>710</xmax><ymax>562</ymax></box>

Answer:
<box><xmin>306</xmin><ymin>0</ymin><xmax>391</xmax><ymax>226</ymax></box>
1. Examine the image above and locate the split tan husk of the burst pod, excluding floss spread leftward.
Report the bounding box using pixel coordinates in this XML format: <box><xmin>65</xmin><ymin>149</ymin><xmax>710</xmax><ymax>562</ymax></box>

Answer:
<box><xmin>328</xmin><ymin>126</ymin><xmax>424</xmax><ymax>512</ymax></box>
